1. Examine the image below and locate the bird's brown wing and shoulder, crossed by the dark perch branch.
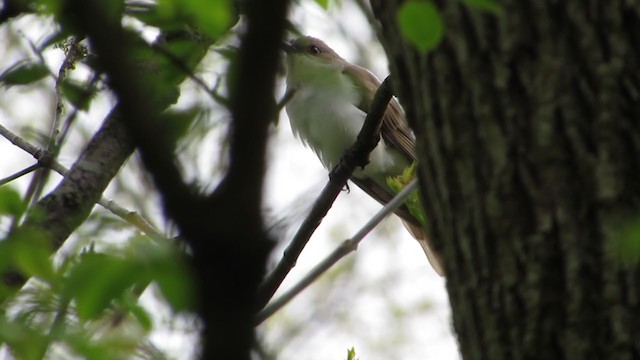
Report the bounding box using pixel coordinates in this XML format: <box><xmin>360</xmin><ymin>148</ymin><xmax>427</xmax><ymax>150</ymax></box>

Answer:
<box><xmin>343</xmin><ymin>64</ymin><xmax>416</xmax><ymax>162</ymax></box>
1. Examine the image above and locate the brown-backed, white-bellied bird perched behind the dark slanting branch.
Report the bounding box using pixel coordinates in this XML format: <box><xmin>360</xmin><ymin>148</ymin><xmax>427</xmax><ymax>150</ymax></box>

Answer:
<box><xmin>282</xmin><ymin>36</ymin><xmax>444</xmax><ymax>276</ymax></box>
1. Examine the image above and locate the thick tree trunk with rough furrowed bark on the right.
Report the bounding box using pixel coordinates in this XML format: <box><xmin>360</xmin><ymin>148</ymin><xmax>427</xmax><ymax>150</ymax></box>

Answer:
<box><xmin>371</xmin><ymin>0</ymin><xmax>640</xmax><ymax>360</ymax></box>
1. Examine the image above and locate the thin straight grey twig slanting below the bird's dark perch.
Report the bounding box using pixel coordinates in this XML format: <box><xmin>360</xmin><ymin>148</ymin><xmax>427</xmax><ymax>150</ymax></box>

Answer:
<box><xmin>256</xmin><ymin>179</ymin><xmax>418</xmax><ymax>325</ymax></box>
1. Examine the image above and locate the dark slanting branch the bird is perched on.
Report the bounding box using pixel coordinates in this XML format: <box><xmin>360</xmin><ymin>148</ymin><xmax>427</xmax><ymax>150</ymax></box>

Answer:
<box><xmin>257</xmin><ymin>77</ymin><xmax>393</xmax><ymax>308</ymax></box>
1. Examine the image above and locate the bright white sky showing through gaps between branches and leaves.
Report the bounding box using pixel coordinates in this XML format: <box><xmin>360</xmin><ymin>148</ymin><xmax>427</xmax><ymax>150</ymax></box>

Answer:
<box><xmin>0</xmin><ymin>1</ymin><xmax>460</xmax><ymax>360</ymax></box>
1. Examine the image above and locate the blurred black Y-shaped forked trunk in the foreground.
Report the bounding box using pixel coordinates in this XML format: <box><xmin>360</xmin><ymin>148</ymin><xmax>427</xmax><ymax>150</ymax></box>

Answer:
<box><xmin>69</xmin><ymin>0</ymin><xmax>287</xmax><ymax>359</ymax></box>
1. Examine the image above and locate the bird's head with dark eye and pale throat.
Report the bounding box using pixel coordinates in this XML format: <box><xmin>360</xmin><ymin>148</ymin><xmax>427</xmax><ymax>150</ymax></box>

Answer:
<box><xmin>282</xmin><ymin>36</ymin><xmax>345</xmax><ymax>85</ymax></box>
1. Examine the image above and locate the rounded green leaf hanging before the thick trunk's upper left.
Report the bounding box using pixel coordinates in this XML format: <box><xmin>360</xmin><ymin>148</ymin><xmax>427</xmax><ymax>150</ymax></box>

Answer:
<box><xmin>396</xmin><ymin>0</ymin><xmax>444</xmax><ymax>52</ymax></box>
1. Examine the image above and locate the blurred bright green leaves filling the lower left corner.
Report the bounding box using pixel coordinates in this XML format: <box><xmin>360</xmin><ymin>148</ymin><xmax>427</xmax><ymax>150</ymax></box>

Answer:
<box><xmin>0</xmin><ymin>228</ymin><xmax>193</xmax><ymax>359</ymax></box>
